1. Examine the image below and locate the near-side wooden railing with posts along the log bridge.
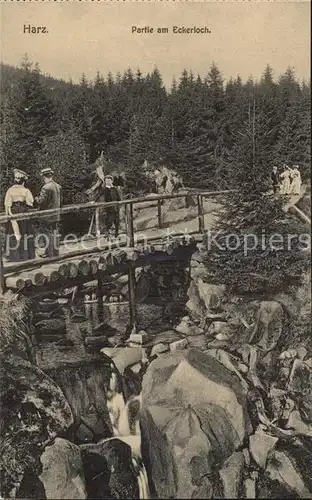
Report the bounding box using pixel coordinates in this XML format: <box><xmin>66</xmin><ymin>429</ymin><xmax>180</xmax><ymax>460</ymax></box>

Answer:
<box><xmin>0</xmin><ymin>190</ymin><xmax>234</xmax><ymax>292</ymax></box>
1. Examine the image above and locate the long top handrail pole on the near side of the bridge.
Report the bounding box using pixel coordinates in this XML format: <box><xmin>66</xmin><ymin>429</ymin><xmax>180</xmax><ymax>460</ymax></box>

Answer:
<box><xmin>0</xmin><ymin>189</ymin><xmax>236</xmax><ymax>224</ymax></box>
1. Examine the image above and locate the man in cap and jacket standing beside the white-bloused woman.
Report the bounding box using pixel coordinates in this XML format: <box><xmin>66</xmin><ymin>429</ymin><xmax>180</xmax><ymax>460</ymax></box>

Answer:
<box><xmin>35</xmin><ymin>167</ymin><xmax>62</xmax><ymax>257</ymax></box>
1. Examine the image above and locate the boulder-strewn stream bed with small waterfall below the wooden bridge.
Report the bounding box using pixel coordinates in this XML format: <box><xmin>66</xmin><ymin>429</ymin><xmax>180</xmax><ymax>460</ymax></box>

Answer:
<box><xmin>0</xmin><ymin>251</ymin><xmax>312</xmax><ymax>499</ymax></box>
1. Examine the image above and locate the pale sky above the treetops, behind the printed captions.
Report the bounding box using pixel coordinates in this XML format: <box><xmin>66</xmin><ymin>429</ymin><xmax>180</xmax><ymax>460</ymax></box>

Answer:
<box><xmin>0</xmin><ymin>0</ymin><xmax>310</xmax><ymax>85</ymax></box>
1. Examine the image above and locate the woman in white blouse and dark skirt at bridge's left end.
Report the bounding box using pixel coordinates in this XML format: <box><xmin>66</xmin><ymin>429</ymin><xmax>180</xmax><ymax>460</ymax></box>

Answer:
<box><xmin>4</xmin><ymin>168</ymin><xmax>35</xmax><ymax>261</ymax></box>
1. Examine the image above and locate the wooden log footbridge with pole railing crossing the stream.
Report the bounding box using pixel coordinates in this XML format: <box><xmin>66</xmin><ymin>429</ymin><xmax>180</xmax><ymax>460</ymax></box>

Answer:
<box><xmin>0</xmin><ymin>191</ymin><xmax>230</xmax><ymax>326</ymax></box>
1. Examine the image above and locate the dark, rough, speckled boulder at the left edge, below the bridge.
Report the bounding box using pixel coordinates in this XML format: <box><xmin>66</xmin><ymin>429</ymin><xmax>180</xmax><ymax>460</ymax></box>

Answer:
<box><xmin>0</xmin><ymin>356</ymin><xmax>73</xmax><ymax>496</ymax></box>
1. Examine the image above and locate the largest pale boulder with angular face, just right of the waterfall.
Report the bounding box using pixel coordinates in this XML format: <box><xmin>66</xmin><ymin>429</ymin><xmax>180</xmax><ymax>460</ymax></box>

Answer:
<box><xmin>141</xmin><ymin>348</ymin><xmax>251</xmax><ymax>498</ymax></box>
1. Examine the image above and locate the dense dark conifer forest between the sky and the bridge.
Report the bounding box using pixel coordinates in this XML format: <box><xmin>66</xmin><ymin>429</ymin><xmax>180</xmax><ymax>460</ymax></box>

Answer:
<box><xmin>0</xmin><ymin>57</ymin><xmax>311</xmax><ymax>204</ymax></box>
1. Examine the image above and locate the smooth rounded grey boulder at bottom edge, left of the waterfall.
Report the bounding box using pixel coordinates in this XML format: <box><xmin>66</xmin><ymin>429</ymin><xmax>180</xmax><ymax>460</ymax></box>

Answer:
<box><xmin>39</xmin><ymin>438</ymin><xmax>87</xmax><ymax>500</ymax></box>
